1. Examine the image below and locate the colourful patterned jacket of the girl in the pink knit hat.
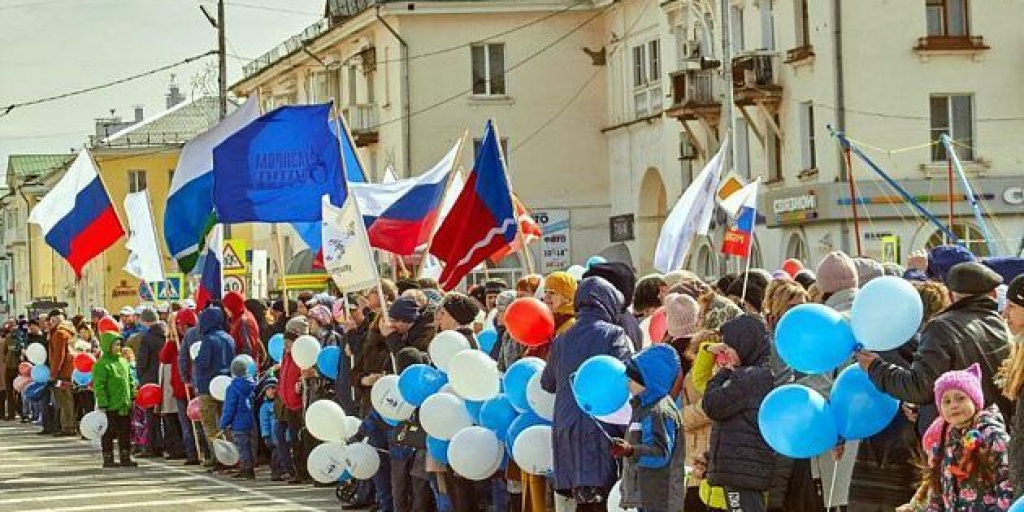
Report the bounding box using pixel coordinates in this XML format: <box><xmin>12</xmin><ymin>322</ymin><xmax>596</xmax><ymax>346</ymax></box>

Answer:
<box><xmin>927</xmin><ymin>407</ymin><xmax>1014</xmax><ymax>512</ymax></box>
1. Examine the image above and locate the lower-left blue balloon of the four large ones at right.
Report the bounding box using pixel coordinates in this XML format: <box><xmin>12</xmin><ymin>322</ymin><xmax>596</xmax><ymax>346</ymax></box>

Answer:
<box><xmin>758</xmin><ymin>384</ymin><xmax>840</xmax><ymax>459</ymax></box>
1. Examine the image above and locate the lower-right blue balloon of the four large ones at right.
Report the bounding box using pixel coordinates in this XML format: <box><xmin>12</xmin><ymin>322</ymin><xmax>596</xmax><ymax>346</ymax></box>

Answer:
<box><xmin>829</xmin><ymin>365</ymin><xmax>899</xmax><ymax>439</ymax></box>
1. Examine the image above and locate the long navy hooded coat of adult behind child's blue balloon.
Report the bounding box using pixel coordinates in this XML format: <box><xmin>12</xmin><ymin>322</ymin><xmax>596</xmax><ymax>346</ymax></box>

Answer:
<box><xmin>541</xmin><ymin>276</ymin><xmax>630</xmax><ymax>490</ymax></box>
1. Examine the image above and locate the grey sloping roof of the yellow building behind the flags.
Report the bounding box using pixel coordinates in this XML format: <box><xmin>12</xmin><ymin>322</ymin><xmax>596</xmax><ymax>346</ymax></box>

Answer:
<box><xmin>96</xmin><ymin>96</ymin><xmax>220</xmax><ymax>147</ymax></box>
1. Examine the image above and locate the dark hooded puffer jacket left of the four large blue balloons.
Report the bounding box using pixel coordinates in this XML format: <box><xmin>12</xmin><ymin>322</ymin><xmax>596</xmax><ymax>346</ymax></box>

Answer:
<box><xmin>700</xmin><ymin>314</ymin><xmax>775</xmax><ymax>490</ymax></box>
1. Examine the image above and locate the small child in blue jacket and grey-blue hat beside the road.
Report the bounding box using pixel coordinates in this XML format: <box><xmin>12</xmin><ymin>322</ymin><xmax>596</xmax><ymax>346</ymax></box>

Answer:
<box><xmin>219</xmin><ymin>356</ymin><xmax>256</xmax><ymax>480</ymax></box>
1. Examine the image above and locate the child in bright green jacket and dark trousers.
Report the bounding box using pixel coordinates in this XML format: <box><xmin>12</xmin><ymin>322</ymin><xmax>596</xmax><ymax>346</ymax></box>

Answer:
<box><xmin>92</xmin><ymin>332</ymin><xmax>138</xmax><ymax>468</ymax></box>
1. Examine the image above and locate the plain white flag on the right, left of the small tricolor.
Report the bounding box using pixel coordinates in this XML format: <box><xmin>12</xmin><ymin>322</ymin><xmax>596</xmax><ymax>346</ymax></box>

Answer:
<box><xmin>654</xmin><ymin>137</ymin><xmax>729</xmax><ymax>272</ymax></box>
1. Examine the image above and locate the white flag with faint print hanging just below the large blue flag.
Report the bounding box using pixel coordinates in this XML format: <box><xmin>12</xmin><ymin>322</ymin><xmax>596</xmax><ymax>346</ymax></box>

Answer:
<box><xmin>322</xmin><ymin>194</ymin><xmax>380</xmax><ymax>292</ymax></box>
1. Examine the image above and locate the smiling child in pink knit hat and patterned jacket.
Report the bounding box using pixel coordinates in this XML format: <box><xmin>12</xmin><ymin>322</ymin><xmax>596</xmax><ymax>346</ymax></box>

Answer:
<box><xmin>897</xmin><ymin>364</ymin><xmax>1014</xmax><ymax>512</ymax></box>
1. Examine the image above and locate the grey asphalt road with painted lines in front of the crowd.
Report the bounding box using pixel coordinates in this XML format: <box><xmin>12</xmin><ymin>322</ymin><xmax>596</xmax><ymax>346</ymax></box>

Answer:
<box><xmin>0</xmin><ymin>421</ymin><xmax>356</xmax><ymax>512</ymax></box>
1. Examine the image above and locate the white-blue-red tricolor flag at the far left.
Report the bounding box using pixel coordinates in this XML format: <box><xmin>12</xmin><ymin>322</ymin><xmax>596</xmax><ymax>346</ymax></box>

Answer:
<box><xmin>29</xmin><ymin>150</ymin><xmax>125</xmax><ymax>279</ymax></box>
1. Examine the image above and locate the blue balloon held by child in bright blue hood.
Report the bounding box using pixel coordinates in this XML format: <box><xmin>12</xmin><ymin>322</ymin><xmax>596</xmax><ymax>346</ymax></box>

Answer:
<box><xmin>572</xmin><ymin>355</ymin><xmax>630</xmax><ymax>416</ymax></box>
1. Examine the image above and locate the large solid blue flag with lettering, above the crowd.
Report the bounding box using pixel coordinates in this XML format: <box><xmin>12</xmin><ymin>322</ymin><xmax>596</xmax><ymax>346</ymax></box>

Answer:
<box><xmin>213</xmin><ymin>103</ymin><xmax>345</xmax><ymax>223</ymax></box>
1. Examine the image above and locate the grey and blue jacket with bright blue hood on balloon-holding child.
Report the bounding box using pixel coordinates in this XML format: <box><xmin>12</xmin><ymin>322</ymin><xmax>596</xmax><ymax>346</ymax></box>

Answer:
<box><xmin>622</xmin><ymin>345</ymin><xmax>686</xmax><ymax>512</ymax></box>
